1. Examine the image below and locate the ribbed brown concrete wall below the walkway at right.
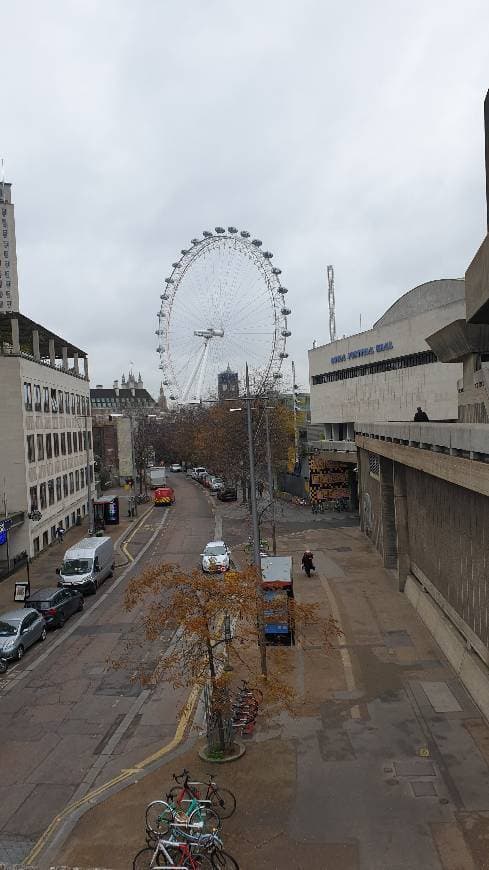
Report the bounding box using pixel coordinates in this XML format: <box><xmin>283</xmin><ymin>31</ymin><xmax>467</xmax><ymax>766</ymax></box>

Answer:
<box><xmin>358</xmin><ymin>445</ymin><xmax>489</xmax><ymax>663</ymax></box>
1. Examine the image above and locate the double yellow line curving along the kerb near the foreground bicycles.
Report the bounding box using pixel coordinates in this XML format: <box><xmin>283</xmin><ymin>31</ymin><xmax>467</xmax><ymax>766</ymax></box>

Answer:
<box><xmin>25</xmin><ymin>686</ymin><xmax>200</xmax><ymax>864</ymax></box>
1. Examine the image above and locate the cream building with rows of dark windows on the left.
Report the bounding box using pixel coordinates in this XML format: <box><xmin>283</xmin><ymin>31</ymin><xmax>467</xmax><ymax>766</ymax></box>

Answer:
<box><xmin>0</xmin><ymin>313</ymin><xmax>93</xmax><ymax>572</ymax></box>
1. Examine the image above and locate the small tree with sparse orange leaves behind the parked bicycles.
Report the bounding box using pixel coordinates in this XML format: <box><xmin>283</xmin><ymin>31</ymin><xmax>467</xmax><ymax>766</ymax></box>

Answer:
<box><xmin>114</xmin><ymin>564</ymin><xmax>339</xmax><ymax>755</ymax></box>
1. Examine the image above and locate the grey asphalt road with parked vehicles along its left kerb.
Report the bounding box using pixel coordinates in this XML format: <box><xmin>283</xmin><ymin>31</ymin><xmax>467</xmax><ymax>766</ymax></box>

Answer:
<box><xmin>0</xmin><ymin>478</ymin><xmax>214</xmax><ymax>863</ymax></box>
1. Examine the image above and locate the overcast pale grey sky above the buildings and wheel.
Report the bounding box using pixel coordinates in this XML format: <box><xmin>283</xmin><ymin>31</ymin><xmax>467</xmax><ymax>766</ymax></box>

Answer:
<box><xmin>0</xmin><ymin>0</ymin><xmax>489</xmax><ymax>391</ymax></box>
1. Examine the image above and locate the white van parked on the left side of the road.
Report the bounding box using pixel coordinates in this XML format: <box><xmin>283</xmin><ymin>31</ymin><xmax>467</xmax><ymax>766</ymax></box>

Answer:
<box><xmin>56</xmin><ymin>537</ymin><xmax>114</xmax><ymax>592</ymax></box>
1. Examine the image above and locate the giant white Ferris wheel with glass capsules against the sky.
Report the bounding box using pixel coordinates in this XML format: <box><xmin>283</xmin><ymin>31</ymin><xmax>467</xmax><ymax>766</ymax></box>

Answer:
<box><xmin>156</xmin><ymin>227</ymin><xmax>291</xmax><ymax>405</ymax></box>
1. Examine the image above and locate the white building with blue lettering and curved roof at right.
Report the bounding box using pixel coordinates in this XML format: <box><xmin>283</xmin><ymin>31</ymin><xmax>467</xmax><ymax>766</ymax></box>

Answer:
<box><xmin>309</xmin><ymin>279</ymin><xmax>465</xmax><ymax>442</ymax></box>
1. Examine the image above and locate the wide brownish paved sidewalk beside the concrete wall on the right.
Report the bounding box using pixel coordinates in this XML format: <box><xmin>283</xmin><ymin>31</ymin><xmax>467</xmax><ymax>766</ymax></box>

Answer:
<box><xmin>53</xmin><ymin>528</ymin><xmax>489</xmax><ymax>870</ymax></box>
